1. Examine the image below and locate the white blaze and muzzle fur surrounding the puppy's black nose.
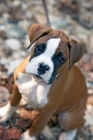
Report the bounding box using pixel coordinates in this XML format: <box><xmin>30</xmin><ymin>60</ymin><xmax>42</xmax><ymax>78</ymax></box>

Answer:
<box><xmin>26</xmin><ymin>38</ymin><xmax>61</xmax><ymax>83</ymax></box>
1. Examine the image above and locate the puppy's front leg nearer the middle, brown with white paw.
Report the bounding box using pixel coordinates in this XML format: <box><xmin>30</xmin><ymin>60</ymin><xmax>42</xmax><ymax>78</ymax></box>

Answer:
<box><xmin>20</xmin><ymin>105</ymin><xmax>56</xmax><ymax>140</ymax></box>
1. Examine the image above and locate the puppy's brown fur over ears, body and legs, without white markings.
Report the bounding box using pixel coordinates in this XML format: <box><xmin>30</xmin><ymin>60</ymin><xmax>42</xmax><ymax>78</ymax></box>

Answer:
<box><xmin>10</xmin><ymin>24</ymin><xmax>87</xmax><ymax>136</ymax></box>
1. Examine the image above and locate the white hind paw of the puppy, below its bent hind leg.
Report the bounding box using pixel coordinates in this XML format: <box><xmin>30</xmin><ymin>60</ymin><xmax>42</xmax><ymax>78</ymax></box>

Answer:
<box><xmin>59</xmin><ymin>129</ymin><xmax>77</xmax><ymax>140</ymax></box>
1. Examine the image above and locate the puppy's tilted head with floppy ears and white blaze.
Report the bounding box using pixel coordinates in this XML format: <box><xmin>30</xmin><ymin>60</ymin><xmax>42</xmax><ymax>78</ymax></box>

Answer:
<box><xmin>26</xmin><ymin>24</ymin><xmax>84</xmax><ymax>84</ymax></box>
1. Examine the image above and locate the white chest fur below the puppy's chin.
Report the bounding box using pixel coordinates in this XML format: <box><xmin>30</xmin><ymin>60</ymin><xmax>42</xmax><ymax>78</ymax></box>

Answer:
<box><xmin>16</xmin><ymin>73</ymin><xmax>51</xmax><ymax>108</ymax></box>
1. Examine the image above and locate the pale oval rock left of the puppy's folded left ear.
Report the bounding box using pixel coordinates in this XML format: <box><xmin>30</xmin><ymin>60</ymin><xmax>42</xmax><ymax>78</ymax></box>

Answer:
<box><xmin>5</xmin><ymin>38</ymin><xmax>21</xmax><ymax>50</ymax></box>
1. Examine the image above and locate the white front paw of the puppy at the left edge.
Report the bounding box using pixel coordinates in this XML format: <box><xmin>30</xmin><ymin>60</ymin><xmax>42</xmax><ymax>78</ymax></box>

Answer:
<box><xmin>0</xmin><ymin>103</ymin><xmax>16</xmax><ymax>123</ymax></box>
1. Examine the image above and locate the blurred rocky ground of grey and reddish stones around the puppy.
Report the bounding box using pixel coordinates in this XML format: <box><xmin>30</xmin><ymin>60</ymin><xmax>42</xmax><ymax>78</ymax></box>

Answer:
<box><xmin>0</xmin><ymin>0</ymin><xmax>93</xmax><ymax>140</ymax></box>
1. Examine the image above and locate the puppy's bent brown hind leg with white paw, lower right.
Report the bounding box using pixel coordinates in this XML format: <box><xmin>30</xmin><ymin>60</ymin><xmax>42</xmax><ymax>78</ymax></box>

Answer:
<box><xmin>58</xmin><ymin>109</ymin><xmax>85</xmax><ymax>140</ymax></box>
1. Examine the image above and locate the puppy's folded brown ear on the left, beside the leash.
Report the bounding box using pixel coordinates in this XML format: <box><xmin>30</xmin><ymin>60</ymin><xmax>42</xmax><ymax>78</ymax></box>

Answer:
<box><xmin>27</xmin><ymin>24</ymin><xmax>52</xmax><ymax>49</ymax></box>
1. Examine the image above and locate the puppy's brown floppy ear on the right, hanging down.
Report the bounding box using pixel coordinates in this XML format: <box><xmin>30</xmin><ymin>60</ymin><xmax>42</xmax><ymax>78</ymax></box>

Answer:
<box><xmin>68</xmin><ymin>39</ymin><xmax>85</xmax><ymax>71</ymax></box>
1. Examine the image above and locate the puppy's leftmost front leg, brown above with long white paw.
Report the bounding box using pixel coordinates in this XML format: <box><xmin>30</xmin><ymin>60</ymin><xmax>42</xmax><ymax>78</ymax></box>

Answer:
<box><xmin>0</xmin><ymin>84</ymin><xmax>21</xmax><ymax>123</ymax></box>
